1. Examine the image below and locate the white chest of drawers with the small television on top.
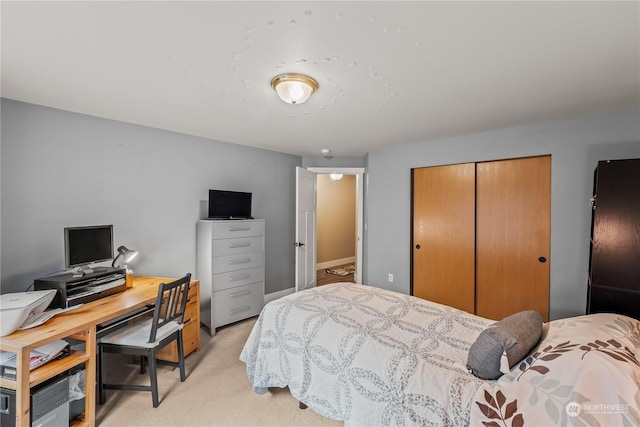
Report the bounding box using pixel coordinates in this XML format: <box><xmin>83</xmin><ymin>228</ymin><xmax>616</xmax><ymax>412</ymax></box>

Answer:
<box><xmin>196</xmin><ymin>219</ymin><xmax>264</xmax><ymax>336</ymax></box>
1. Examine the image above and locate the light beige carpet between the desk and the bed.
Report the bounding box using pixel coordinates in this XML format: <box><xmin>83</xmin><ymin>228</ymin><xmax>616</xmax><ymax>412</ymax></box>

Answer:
<box><xmin>96</xmin><ymin>318</ymin><xmax>343</xmax><ymax>427</ymax></box>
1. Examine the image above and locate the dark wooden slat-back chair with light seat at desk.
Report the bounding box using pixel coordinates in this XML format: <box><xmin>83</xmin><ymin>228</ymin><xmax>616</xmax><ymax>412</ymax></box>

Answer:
<box><xmin>98</xmin><ymin>273</ymin><xmax>191</xmax><ymax>408</ymax></box>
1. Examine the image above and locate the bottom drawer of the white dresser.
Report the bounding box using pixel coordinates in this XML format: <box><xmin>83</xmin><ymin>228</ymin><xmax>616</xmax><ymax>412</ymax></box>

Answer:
<box><xmin>211</xmin><ymin>282</ymin><xmax>264</xmax><ymax>327</ymax></box>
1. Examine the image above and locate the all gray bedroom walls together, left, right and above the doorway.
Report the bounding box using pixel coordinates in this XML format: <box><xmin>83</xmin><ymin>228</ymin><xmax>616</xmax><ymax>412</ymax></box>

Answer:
<box><xmin>0</xmin><ymin>99</ymin><xmax>640</xmax><ymax>318</ymax></box>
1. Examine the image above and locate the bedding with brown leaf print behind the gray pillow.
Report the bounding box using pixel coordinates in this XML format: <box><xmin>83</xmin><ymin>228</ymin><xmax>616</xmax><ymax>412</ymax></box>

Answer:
<box><xmin>471</xmin><ymin>314</ymin><xmax>640</xmax><ymax>427</ymax></box>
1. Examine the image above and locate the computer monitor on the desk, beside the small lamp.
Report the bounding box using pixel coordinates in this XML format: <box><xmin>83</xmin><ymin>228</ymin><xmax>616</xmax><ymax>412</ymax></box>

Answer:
<box><xmin>64</xmin><ymin>225</ymin><xmax>113</xmax><ymax>268</ymax></box>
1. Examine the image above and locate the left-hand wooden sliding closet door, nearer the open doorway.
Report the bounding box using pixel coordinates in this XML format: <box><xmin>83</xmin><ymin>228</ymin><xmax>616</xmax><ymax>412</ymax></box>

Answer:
<box><xmin>412</xmin><ymin>163</ymin><xmax>475</xmax><ymax>313</ymax></box>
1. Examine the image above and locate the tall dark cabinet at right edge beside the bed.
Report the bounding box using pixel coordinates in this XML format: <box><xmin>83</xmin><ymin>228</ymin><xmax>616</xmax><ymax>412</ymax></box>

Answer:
<box><xmin>587</xmin><ymin>159</ymin><xmax>640</xmax><ymax>319</ymax></box>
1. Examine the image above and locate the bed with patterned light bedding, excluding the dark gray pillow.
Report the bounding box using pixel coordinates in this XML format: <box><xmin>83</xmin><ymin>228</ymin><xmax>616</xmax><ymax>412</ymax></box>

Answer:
<box><xmin>240</xmin><ymin>283</ymin><xmax>640</xmax><ymax>426</ymax></box>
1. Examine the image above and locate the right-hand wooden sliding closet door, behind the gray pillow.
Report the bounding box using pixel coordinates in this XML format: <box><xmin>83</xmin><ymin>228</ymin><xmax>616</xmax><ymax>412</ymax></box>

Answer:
<box><xmin>476</xmin><ymin>156</ymin><xmax>551</xmax><ymax>321</ymax></box>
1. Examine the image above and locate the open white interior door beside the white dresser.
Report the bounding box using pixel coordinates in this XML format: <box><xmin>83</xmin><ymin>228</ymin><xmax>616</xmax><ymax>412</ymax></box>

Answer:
<box><xmin>294</xmin><ymin>167</ymin><xmax>318</xmax><ymax>292</ymax></box>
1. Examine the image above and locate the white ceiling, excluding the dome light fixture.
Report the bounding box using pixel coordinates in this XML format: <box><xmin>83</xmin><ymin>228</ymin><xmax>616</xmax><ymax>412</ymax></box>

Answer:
<box><xmin>0</xmin><ymin>1</ymin><xmax>640</xmax><ymax>156</ymax></box>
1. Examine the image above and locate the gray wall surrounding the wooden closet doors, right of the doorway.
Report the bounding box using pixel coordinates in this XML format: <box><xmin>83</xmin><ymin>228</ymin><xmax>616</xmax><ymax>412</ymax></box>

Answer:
<box><xmin>363</xmin><ymin>110</ymin><xmax>640</xmax><ymax>319</ymax></box>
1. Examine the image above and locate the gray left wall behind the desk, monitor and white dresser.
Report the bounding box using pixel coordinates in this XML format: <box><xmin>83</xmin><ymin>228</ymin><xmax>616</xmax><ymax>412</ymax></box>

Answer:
<box><xmin>0</xmin><ymin>99</ymin><xmax>302</xmax><ymax>293</ymax></box>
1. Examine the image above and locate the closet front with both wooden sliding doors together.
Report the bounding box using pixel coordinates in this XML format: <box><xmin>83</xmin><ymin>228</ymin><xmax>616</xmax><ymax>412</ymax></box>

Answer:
<box><xmin>411</xmin><ymin>156</ymin><xmax>551</xmax><ymax>320</ymax></box>
